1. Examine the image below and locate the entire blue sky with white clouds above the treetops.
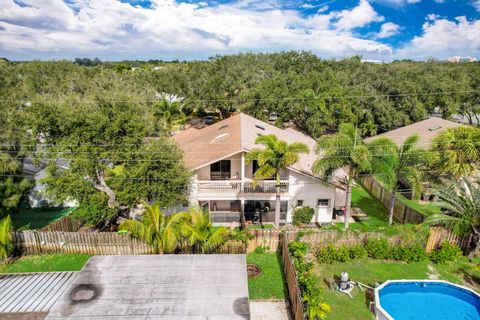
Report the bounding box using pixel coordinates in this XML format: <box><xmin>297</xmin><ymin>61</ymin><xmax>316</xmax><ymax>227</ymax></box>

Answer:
<box><xmin>0</xmin><ymin>0</ymin><xmax>480</xmax><ymax>61</ymax></box>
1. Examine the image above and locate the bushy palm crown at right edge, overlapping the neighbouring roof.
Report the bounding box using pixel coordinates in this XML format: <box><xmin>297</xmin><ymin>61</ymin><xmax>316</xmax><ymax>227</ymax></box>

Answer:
<box><xmin>432</xmin><ymin>126</ymin><xmax>480</xmax><ymax>179</ymax></box>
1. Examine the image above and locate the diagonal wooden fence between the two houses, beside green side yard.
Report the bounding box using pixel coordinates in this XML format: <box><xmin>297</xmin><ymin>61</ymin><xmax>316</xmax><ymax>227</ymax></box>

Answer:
<box><xmin>360</xmin><ymin>176</ymin><xmax>425</xmax><ymax>224</ymax></box>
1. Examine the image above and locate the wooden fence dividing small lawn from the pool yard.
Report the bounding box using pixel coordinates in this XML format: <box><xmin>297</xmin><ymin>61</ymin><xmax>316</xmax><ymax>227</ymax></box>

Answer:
<box><xmin>281</xmin><ymin>239</ymin><xmax>305</xmax><ymax>320</ymax></box>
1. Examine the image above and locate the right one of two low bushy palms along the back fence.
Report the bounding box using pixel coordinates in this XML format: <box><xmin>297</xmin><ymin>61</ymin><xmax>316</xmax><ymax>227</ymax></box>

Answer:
<box><xmin>181</xmin><ymin>209</ymin><xmax>229</xmax><ymax>253</ymax></box>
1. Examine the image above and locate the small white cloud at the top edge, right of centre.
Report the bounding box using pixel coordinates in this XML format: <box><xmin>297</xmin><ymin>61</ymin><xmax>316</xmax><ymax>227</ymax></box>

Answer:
<box><xmin>336</xmin><ymin>0</ymin><xmax>385</xmax><ymax>30</ymax></box>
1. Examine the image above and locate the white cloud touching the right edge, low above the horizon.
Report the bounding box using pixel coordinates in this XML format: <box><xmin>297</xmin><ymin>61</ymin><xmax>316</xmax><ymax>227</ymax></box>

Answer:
<box><xmin>399</xmin><ymin>16</ymin><xmax>480</xmax><ymax>58</ymax></box>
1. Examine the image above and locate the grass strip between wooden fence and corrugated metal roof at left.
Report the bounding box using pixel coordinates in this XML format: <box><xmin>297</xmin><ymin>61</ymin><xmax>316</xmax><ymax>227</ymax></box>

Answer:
<box><xmin>0</xmin><ymin>254</ymin><xmax>91</xmax><ymax>273</ymax></box>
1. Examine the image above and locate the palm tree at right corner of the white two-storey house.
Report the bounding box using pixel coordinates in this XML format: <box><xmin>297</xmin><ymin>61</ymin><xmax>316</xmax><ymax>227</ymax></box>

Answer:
<box><xmin>313</xmin><ymin>123</ymin><xmax>371</xmax><ymax>229</ymax></box>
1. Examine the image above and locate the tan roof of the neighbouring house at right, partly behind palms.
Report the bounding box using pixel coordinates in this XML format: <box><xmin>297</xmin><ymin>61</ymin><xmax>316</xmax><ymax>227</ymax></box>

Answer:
<box><xmin>365</xmin><ymin>117</ymin><xmax>463</xmax><ymax>148</ymax></box>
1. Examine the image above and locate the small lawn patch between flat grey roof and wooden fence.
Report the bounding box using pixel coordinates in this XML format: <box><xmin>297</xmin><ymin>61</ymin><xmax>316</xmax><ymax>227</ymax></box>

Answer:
<box><xmin>247</xmin><ymin>253</ymin><xmax>287</xmax><ymax>300</ymax></box>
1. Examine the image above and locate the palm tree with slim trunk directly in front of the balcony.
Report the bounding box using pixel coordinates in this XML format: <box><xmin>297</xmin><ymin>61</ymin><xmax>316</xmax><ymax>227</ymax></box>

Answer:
<box><xmin>245</xmin><ymin>134</ymin><xmax>308</xmax><ymax>229</ymax></box>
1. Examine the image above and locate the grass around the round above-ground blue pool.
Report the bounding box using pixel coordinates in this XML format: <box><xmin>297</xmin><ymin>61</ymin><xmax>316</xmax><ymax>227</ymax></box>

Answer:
<box><xmin>315</xmin><ymin>257</ymin><xmax>480</xmax><ymax>320</ymax></box>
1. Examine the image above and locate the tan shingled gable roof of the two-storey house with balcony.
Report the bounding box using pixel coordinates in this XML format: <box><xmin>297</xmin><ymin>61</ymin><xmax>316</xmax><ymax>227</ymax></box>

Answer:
<box><xmin>173</xmin><ymin>113</ymin><xmax>316</xmax><ymax>175</ymax></box>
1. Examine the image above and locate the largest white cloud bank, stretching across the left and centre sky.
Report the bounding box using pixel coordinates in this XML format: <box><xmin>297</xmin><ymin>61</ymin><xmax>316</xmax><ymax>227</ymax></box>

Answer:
<box><xmin>0</xmin><ymin>0</ymin><xmax>392</xmax><ymax>58</ymax></box>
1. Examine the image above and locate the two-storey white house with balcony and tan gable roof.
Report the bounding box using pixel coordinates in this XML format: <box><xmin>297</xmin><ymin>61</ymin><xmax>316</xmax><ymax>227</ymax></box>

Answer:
<box><xmin>172</xmin><ymin>113</ymin><xmax>345</xmax><ymax>224</ymax></box>
